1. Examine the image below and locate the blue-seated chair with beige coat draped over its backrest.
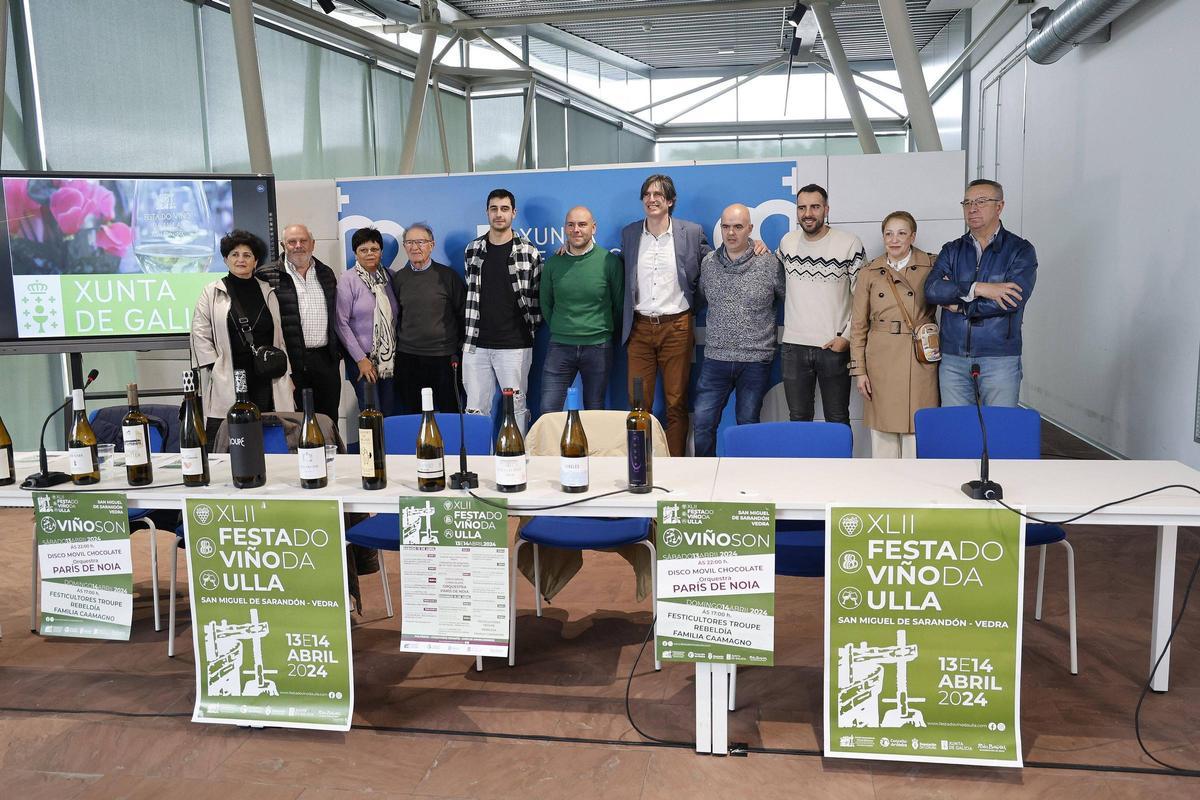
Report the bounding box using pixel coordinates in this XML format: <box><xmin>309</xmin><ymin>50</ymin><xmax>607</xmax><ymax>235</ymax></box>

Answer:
<box><xmin>509</xmin><ymin>410</ymin><xmax>667</xmax><ymax>669</ymax></box>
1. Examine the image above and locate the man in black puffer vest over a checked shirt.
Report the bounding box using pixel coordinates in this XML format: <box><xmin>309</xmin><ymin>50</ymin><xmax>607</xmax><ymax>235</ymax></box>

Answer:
<box><xmin>256</xmin><ymin>224</ymin><xmax>342</xmax><ymax>425</ymax></box>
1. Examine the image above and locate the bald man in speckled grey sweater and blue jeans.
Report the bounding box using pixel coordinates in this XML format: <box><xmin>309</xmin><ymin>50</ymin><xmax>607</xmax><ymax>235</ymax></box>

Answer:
<box><xmin>692</xmin><ymin>204</ymin><xmax>784</xmax><ymax>456</ymax></box>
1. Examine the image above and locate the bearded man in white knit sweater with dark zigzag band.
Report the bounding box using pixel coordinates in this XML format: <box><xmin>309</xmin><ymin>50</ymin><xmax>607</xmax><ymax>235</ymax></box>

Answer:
<box><xmin>775</xmin><ymin>184</ymin><xmax>865</xmax><ymax>425</ymax></box>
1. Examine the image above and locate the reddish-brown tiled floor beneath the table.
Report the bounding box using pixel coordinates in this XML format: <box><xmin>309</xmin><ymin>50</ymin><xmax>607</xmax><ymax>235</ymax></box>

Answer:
<box><xmin>0</xmin><ymin>431</ymin><xmax>1200</xmax><ymax>800</ymax></box>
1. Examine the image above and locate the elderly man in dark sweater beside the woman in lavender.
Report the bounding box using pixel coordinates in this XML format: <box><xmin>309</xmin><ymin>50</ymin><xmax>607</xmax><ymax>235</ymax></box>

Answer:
<box><xmin>391</xmin><ymin>222</ymin><xmax>467</xmax><ymax>414</ymax></box>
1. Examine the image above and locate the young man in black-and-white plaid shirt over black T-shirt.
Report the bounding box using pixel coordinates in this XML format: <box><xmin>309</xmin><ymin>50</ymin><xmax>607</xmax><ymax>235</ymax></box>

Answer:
<box><xmin>462</xmin><ymin>188</ymin><xmax>542</xmax><ymax>433</ymax></box>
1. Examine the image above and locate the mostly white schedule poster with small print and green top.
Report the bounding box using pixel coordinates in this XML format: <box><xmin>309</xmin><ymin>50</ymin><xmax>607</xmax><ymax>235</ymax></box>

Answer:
<box><xmin>396</xmin><ymin>498</ymin><xmax>511</xmax><ymax>657</ymax></box>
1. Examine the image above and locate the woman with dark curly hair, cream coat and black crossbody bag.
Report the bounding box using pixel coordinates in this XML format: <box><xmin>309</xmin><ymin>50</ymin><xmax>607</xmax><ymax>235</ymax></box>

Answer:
<box><xmin>192</xmin><ymin>230</ymin><xmax>295</xmax><ymax>447</ymax></box>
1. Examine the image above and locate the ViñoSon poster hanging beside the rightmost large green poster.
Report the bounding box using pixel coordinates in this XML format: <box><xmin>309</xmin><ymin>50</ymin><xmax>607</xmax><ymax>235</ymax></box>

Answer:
<box><xmin>655</xmin><ymin>500</ymin><xmax>775</xmax><ymax>667</ymax></box>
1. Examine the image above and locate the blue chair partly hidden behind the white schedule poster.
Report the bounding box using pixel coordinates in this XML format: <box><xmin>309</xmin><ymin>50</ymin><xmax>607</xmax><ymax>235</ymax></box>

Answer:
<box><xmin>346</xmin><ymin>414</ymin><xmax>492</xmax><ymax>618</ymax></box>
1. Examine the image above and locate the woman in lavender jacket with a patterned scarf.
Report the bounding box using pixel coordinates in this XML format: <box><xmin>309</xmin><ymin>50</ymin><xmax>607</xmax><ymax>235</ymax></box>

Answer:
<box><xmin>336</xmin><ymin>228</ymin><xmax>396</xmax><ymax>414</ymax></box>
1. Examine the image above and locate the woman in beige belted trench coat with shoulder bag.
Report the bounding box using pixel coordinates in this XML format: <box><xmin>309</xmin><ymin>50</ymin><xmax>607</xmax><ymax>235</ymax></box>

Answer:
<box><xmin>850</xmin><ymin>211</ymin><xmax>938</xmax><ymax>458</ymax></box>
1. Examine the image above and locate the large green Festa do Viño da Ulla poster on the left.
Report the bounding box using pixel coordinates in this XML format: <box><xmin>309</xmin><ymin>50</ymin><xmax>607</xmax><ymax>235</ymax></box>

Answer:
<box><xmin>184</xmin><ymin>497</ymin><xmax>354</xmax><ymax>730</ymax></box>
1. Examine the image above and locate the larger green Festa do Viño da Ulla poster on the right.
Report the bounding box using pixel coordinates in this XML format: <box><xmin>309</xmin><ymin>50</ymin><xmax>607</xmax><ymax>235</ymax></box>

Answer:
<box><xmin>824</xmin><ymin>506</ymin><xmax>1025</xmax><ymax>766</ymax></box>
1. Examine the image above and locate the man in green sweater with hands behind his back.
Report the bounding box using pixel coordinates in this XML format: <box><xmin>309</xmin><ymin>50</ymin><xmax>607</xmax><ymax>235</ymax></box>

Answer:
<box><xmin>541</xmin><ymin>205</ymin><xmax>625</xmax><ymax>414</ymax></box>
